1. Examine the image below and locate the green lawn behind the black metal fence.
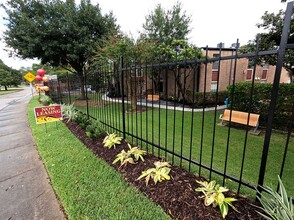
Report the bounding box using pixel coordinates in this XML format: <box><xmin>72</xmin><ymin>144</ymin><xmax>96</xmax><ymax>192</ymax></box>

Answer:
<box><xmin>68</xmin><ymin>93</ymin><xmax>294</xmax><ymax>199</ymax></box>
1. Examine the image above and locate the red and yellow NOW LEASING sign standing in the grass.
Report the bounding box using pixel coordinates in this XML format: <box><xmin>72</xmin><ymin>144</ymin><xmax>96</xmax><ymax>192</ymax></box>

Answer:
<box><xmin>35</xmin><ymin>105</ymin><xmax>62</xmax><ymax>124</ymax></box>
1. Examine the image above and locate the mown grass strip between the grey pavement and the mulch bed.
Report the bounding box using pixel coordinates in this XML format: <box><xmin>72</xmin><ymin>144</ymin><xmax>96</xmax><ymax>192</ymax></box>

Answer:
<box><xmin>28</xmin><ymin>98</ymin><xmax>170</xmax><ymax>220</ymax></box>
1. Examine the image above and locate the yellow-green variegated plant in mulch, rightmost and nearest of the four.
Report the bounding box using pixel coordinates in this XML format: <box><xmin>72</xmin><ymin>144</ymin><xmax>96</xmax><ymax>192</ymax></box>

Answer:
<box><xmin>195</xmin><ymin>180</ymin><xmax>236</xmax><ymax>218</ymax></box>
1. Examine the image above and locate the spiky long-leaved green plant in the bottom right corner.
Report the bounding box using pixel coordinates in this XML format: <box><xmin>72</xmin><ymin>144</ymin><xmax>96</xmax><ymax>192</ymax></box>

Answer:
<box><xmin>257</xmin><ymin>176</ymin><xmax>294</xmax><ymax>220</ymax></box>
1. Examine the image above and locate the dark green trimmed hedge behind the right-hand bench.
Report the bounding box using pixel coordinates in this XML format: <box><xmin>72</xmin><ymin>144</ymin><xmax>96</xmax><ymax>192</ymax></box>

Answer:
<box><xmin>228</xmin><ymin>82</ymin><xmax>294</xmax><ymax>130</ymax></box>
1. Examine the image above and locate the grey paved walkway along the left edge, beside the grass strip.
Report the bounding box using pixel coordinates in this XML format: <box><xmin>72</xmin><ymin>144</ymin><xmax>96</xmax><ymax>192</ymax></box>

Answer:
<box><xmin>0</xmin><ymin>88</ymin><xmax>65</xmax><ymax>220</ymax></box>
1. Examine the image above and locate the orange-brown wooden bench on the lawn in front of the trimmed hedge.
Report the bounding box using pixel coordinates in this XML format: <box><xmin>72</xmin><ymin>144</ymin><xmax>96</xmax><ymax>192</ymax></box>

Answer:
<box><xmin>219</xmin><ymin>109</ymin><xmax>259</xmax><ymax>133</ymax></box>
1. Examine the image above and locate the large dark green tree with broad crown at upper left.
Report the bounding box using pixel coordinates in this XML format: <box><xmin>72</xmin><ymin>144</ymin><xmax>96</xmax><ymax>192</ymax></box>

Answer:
<box><xmin>2</xmin><ymin>0</ymin><xmax>118</xmax><ymax>99</ymax></box>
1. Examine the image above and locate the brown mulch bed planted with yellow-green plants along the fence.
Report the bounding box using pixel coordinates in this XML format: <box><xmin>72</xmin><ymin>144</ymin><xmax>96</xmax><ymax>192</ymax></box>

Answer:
<box><xmin>65</xmin><ymin>122</ymin><xmax>263</xmax><ymax>220</ymax></box>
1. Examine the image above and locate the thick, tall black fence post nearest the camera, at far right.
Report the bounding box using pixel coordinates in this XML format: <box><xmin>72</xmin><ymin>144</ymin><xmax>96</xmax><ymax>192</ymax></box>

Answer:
<box><xmin>257</xmin><ymin>2</ymin><xmax>293</xmax><ymax>198</ymax></box>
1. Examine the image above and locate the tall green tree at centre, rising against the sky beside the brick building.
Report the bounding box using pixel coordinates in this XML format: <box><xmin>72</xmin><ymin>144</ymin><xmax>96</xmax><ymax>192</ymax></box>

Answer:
<box><xmin>143</xmin><ymin>2</ymin><xmax>201</xmax><ymax>100</ymax></box>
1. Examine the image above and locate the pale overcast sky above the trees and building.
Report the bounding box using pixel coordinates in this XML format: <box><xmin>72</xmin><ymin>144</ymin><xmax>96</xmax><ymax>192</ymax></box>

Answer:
<box><xmin>0</xmin><ymin>0</ymin><xmax>286</xmax><ymax>69</ymax></box>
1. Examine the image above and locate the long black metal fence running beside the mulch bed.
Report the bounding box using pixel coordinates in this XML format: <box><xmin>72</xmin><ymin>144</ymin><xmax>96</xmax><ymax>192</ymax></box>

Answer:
<box><xmin>51</xmin><ymin>3</ymin><xmax>294</xmax><ymax>200</ymax></box>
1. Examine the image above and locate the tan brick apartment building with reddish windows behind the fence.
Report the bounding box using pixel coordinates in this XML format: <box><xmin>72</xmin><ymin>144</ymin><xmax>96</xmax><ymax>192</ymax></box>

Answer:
<box><xmin>141</xmin><ymin>47</ymin><xmax>290</xmax><ymax>97</ymax></box>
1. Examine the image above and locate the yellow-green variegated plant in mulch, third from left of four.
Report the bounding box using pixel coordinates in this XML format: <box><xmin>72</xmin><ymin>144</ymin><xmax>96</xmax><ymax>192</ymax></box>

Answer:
<box><xmin>138</xmin><ymin>161</ymin><xmax>171</xmax><ymax>186</ymax></box>
